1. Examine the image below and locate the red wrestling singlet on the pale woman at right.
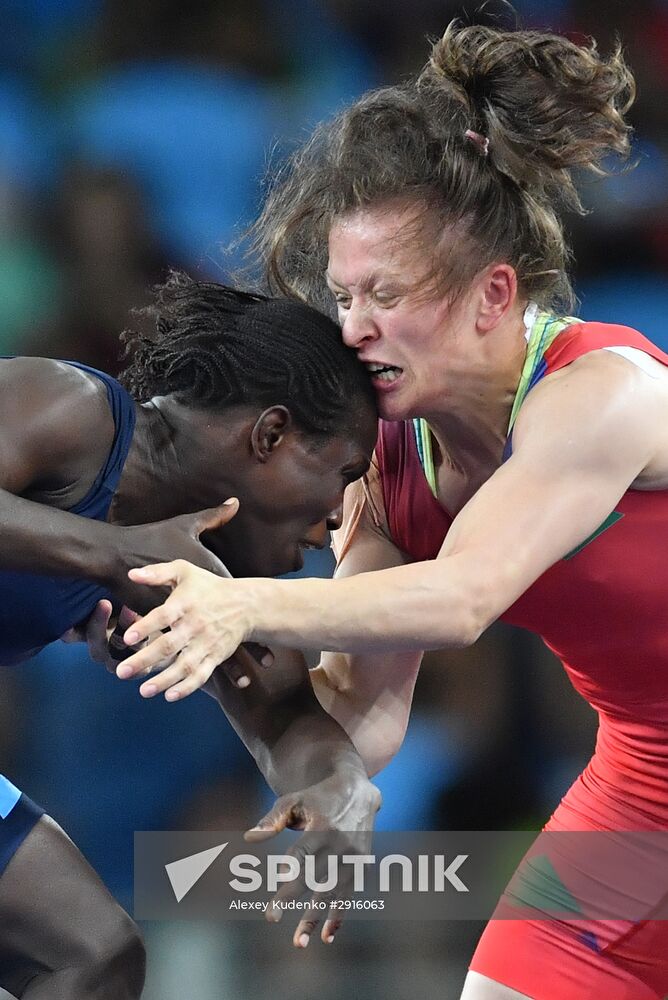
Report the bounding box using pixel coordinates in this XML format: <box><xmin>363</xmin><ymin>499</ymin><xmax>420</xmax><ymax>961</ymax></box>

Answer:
<box><xmin>376</xmin><ymin>323</ymin><xmax>668</xmax><ymax>1000</ymax></box>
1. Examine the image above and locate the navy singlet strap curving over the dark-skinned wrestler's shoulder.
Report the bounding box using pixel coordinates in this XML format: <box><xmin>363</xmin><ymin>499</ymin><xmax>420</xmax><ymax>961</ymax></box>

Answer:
<box><xmin>63</xmin><ymin>361</ymin><xmax>136</xmax><ymax>518</ymax></box>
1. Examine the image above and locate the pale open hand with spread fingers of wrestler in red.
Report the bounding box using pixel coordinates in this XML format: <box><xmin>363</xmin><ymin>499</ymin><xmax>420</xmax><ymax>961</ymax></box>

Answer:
<box><xmin>116</xmin><ymin>559</ymin><xmax>258</xmax><ymax>701</ymax></box>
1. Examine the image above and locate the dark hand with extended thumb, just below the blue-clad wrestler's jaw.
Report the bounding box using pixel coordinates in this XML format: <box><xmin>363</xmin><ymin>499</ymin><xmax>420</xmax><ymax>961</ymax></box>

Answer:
<box><xmin>107</xmin><ymin>497</ymin><xmax>239</xmax><ymax>612</ymax></box>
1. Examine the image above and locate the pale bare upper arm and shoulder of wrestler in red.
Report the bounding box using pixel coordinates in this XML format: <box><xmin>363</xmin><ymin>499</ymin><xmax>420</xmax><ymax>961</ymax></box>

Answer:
<box><xmin>438</xmin><ymin>352</ymin><xmax>665</xmax><ymax>627</ymax></box>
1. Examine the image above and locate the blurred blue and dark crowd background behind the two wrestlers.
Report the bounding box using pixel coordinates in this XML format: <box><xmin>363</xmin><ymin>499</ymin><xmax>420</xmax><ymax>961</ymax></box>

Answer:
<box><xmin>0</xmin><ymin>0</ymin><xmax>668</xmax><ymax>1000</ymax></box>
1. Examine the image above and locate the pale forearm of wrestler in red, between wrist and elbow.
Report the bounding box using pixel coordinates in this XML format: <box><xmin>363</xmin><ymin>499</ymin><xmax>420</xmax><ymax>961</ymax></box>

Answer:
<box><xmin>248</xmin><ymin>558</ymin><xmax>482</xmax><ymax>653</ymax></box>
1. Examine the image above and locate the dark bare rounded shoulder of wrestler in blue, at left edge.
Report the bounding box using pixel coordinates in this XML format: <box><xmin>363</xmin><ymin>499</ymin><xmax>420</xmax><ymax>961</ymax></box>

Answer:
<box><xmin>0</xmin><ymin>357</ymin><xmax>114</xmax><ymax>492</ymax></box>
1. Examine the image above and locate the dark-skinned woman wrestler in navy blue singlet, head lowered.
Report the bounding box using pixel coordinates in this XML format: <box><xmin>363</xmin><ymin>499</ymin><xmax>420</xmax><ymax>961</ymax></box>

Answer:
<box><xmin>0</xmin><ymin>275</ymin><xmax>376</xmax><ymax>1000</ymax></box>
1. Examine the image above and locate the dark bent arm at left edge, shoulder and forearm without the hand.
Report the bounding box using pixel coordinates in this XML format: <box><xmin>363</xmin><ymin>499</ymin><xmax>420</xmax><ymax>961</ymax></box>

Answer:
<box><xmin>0</xmin><ymin>358</ymin><xmax>124</xmax><ymax>582</ymax></box>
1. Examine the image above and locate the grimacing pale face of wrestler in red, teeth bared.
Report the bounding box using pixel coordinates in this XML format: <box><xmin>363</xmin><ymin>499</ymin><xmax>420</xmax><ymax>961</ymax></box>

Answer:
<box><xmin>327</xmin><ymin>204</ymin><xmax>471</xmax><ymax>420</ymax></box>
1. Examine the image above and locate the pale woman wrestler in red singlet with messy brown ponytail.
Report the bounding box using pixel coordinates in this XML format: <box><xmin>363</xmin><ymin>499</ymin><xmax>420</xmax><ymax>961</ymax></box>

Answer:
<box><xmin>112</xmin><ymin>24</ymin><xmax>668</xmax><ymax>1000</ymax></box>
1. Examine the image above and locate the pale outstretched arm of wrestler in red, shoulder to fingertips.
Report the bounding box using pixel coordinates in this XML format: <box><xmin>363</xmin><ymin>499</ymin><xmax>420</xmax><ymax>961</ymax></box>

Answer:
<box><xmin>122</xmin><ymin>352</ymin><xmax>668</xmax><ymax>693</ymax></box>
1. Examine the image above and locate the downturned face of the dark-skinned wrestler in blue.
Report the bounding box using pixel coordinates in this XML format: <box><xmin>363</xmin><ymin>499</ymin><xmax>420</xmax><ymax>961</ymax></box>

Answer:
<box><xmin>213</xmin><ymin>422</ymin><xmax>376</xmax><ymax>576</ymax></box>
